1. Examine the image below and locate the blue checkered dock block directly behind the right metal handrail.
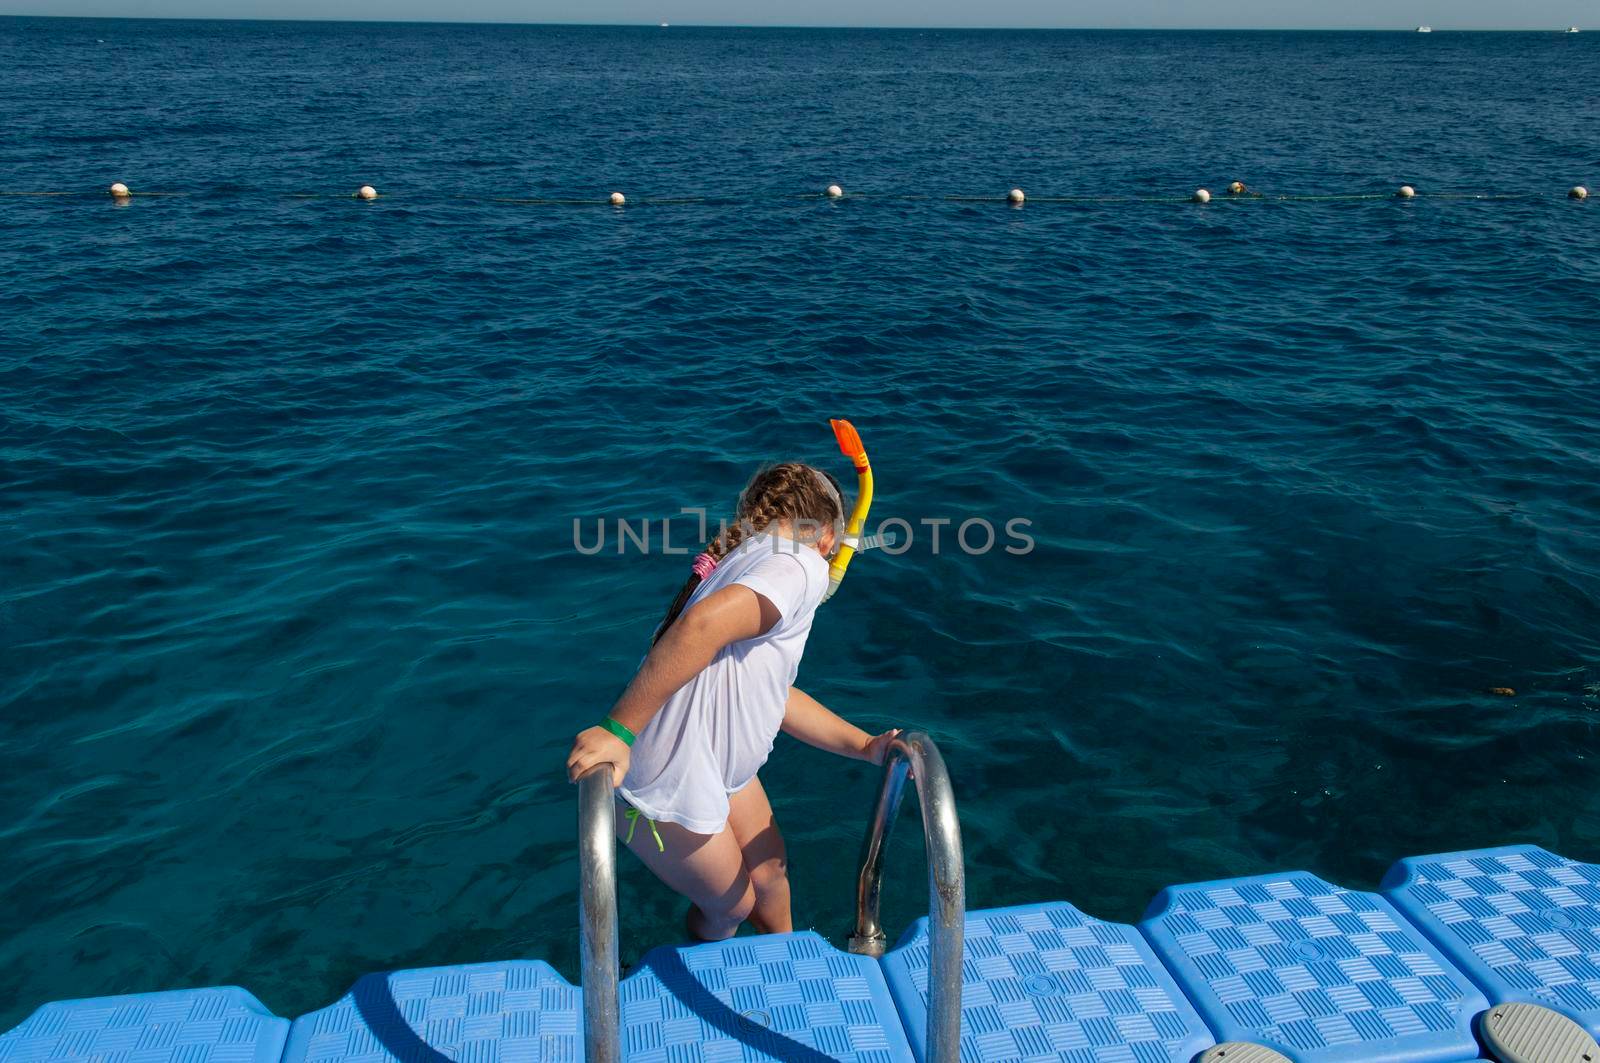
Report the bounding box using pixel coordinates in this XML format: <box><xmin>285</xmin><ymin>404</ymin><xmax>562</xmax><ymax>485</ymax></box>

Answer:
<box><xmin>883</xmin><ymin>903</ymin><xmax>1213</xmax><ymax>1063</ymax></box>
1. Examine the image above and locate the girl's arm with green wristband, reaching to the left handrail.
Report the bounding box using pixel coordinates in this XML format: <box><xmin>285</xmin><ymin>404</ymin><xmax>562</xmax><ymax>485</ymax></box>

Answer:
<box><xmin>566</xmin><ymin>583</ymin><xmax>780</xmax><ymax>786</ymax></box>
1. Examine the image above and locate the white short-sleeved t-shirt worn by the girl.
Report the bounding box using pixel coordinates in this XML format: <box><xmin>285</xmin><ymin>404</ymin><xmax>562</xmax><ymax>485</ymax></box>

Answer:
<box><xmin>618</xmin><ymin>535</ymin><xmax>827</xmax><ymax>834</ymax></box>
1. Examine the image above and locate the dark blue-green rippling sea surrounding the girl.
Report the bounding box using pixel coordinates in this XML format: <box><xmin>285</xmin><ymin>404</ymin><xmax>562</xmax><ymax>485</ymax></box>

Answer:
<box><xmin>0</xmin><ymin>19</ymin><xmax>1600</xmax><ymax>1028</ymax></box>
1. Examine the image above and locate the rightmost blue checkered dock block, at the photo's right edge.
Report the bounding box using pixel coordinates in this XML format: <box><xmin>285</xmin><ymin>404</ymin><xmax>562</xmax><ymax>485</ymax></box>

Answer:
<box><xmin>1382</xmin><ymin>845</ymin><xmax>1600</xmax><ymax>1037</ymax></box>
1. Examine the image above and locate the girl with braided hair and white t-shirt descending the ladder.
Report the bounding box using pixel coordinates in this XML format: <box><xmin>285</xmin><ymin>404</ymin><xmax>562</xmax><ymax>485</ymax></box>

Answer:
<box><xmin>566</xmin><ymin>463</ymin><xmax>898</xmax><ymax>941</ymax></box>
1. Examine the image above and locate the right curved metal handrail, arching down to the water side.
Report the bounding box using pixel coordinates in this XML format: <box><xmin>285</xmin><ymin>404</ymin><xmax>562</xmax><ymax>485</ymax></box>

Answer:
<box><xmin>850</xmin><ymin>732</ymin><xmax>966</xmax><ymax>1063</ymax></box>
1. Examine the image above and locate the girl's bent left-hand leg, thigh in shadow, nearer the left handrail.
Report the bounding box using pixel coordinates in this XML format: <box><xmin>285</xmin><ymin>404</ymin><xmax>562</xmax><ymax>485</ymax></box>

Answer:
<box><xmin>616</xmin><ymin>807</ymin><xmax>755</xmax><ymax>941</ymax></box>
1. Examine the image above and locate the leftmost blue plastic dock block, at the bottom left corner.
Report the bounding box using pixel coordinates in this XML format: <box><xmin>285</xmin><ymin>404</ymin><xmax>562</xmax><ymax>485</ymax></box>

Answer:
<box><xmin>0</xmin><ymin>986</ymin><xmax>290</xmax><ymax>1063</ymax></box>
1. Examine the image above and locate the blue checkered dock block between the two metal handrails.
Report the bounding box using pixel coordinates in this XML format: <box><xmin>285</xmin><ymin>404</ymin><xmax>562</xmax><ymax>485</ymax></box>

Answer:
<box><xmin>622</xmin><ymin>932</ymin><xmax>912</xmax><ymax>1063</ymax></box>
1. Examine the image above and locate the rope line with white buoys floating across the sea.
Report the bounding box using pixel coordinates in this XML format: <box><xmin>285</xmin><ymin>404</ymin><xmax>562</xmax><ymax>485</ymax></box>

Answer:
<box><xmin>0</xmin><ymin>181</ymin><xmax>1589</xmax><ymax>207</ymax></box>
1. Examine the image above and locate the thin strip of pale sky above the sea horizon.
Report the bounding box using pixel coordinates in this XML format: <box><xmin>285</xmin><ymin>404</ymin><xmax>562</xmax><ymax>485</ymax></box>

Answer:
<box><xmin>0</xmin><ymin>0</ymin><xmax>1600</xmax><ymax>30</ymax></box>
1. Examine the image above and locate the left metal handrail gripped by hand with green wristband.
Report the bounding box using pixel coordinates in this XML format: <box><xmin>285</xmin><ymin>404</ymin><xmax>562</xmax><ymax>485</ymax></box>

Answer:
<box><xmin>578</xmin><ymin>764</ymin><xmax>622</xmax><ymax>1063</ymax></box>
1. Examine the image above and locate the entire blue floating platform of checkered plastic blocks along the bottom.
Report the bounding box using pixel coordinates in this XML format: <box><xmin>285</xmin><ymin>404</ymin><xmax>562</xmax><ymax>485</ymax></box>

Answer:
<box><xmin>0</xmin><ymin>845</ymin><xmax>1600</xmax><ymax>1063</ymax></box>
